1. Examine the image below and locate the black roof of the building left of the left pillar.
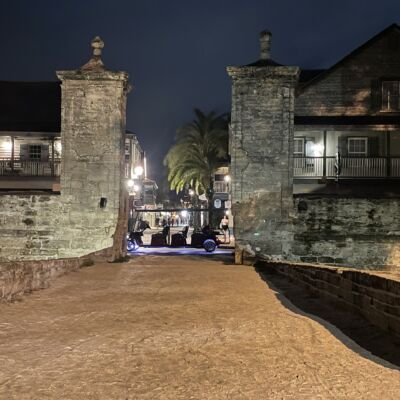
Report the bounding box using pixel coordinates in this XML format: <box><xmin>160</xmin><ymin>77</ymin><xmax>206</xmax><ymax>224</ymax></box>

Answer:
<box><xmin>0</xmin><ymin>81</ymin><xmax>61</xmax><ymax>132</ymax></box>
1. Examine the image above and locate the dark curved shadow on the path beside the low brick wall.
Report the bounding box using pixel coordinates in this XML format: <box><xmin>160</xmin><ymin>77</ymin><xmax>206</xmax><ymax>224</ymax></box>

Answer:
<box><xmin>256</xmin><ymin>268</ymin><xmax>400</xmax><ymax>370</ymax></box>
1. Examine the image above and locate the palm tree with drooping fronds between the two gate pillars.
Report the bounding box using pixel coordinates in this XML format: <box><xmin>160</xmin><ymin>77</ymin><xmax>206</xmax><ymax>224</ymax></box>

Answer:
<box><xmin>164</xmin><ymin>109</ymin><xmax>229</xmax><ymax>224</ymax></box>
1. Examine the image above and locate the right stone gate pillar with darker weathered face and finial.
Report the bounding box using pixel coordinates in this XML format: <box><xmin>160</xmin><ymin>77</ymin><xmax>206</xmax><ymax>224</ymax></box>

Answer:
<box><xmin>227</xmin><ymin>31</ymin><xmax>299</xmax><ymax>262</ymax></box>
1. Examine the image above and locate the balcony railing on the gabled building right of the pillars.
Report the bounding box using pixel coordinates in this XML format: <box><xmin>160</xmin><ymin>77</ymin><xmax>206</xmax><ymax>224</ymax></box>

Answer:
<box><xmin>293</xmin><ymin>157</ymin><xmax>400</xmax><ymax>178</ymax></box>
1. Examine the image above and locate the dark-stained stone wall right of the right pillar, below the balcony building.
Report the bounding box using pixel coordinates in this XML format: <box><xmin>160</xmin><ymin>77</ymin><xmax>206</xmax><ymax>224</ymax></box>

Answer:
<box><xmin>288</xmin><ymin>195</ymin><xmax>400</xmax><ymax>269</ymax></box>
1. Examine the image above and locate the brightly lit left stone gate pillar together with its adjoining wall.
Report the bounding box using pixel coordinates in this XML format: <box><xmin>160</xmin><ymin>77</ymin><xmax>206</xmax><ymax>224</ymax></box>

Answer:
<box><xmin>0</xmin><ymin>37</ymin><xmax>129</xmax><ymax>261</ymax></box>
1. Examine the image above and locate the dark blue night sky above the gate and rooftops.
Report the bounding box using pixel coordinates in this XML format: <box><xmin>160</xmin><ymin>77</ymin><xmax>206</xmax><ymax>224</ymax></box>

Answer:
<box><xmin>0</xmin><ymin>0</ymin><xmax>400</xmax><ymax>179</ymax></box>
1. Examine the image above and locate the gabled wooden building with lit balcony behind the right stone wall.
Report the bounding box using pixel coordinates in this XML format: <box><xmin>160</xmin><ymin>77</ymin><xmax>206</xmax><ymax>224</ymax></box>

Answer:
<box><xmin>293</xmin><ymin>24</ymin><xmax>400</xmax><ymax>188</ymax></box>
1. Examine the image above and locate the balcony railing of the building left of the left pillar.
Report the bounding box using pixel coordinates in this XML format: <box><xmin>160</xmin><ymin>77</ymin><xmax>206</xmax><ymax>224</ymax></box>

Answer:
<box><xmin>0</xmin><ymin>158</ymin><xmax>61</xmax><ymax>176</ymax></box>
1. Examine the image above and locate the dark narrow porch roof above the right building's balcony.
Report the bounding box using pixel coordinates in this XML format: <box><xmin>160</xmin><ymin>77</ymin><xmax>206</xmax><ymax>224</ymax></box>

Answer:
<box><xmin>294</xmin><ymin>115</ymin><xmax>400</xmax><ymax>125</ymax></box>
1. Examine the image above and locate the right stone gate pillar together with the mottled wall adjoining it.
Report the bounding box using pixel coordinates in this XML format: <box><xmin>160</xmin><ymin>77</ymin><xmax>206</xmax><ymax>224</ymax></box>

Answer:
<box><xmin>227</xmin><ymin>32</ymin><xmax>400</xmax><ymax>268</ymax></box>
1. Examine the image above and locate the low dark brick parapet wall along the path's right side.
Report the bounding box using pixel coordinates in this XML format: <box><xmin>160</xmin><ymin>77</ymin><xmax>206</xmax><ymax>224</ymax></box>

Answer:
<box><xmin>256</xmin><ymin>261</ymin><xmax>400</xmax><ymax>336</ymax></box>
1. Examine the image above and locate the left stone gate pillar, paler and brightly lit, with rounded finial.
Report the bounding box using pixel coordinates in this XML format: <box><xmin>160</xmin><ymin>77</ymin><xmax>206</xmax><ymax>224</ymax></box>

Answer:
<box><xmin>57</xmin><ymin>37</ymin><xmax>128</xmax><ymax>258</ymax></box>
